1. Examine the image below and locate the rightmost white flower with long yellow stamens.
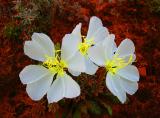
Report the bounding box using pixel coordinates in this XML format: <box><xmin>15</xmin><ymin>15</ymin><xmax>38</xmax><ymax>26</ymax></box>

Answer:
<box><xmin>89</xmin><ymin>37</ymin><xmax>139</xmax><ymax>103</ymax></box>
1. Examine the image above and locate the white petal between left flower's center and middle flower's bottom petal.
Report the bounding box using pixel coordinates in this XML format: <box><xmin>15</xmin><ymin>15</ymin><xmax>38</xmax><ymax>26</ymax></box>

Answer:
<box><xmin>67</xmin><ymin>51</ymin><xmax>85</xmax><ymax>72</ymax></box>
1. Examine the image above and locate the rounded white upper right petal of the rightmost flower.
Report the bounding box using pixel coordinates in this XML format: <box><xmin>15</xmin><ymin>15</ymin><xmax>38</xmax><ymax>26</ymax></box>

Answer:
<box><xmin>116</xmin><ymin>39</ymin><xmax>135</xmax><ymax>57</ymax></box>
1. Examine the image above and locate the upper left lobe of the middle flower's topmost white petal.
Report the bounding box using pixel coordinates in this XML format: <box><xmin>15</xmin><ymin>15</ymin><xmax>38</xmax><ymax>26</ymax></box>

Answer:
<box><xmin>87</xmin><ymin>16</ymin><xmax>103</xmax><ymax>39</ymax></box>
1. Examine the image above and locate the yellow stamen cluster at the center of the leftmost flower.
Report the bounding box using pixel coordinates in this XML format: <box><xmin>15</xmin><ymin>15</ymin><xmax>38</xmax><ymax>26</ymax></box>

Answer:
<box><xmin>43</xmin><ymin>50</ymin><xmax>67</xmax><ymax>76</ymax></box>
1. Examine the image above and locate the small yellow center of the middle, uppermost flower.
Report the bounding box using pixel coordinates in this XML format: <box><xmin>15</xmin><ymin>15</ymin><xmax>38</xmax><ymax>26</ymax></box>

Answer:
<box><xmin>78</xmin><ymin>36</ymin><xmax>94</xmax><ymax>56</ymax></box>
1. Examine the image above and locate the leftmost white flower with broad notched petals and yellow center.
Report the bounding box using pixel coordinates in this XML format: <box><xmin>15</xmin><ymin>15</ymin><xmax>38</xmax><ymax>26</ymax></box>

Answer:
<box><xmin>19</xmin><ymin>33</ymin><xmax>85</xmax><ymax>103</ymax></box>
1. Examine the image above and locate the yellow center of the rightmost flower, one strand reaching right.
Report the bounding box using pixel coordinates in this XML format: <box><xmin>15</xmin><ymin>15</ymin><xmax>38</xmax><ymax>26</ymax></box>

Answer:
<box><xmin>105</xmin><ymin>54</ymin><xmax>133</xmax><ymax>75</ymax></box>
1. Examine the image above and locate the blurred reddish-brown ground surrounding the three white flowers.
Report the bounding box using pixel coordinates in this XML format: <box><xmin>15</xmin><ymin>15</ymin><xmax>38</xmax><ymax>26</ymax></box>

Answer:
<box><xmin>0</xmin><ymin>0</ymin><xmax>160</xmax><ymax>118</ymax></box>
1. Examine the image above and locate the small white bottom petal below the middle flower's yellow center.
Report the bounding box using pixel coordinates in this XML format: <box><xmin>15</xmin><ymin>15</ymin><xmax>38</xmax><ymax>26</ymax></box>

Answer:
<box><xmin>85</xmin><ymin>58</ymin><xmax>98</xmax><ymax>75</ymax></box>
